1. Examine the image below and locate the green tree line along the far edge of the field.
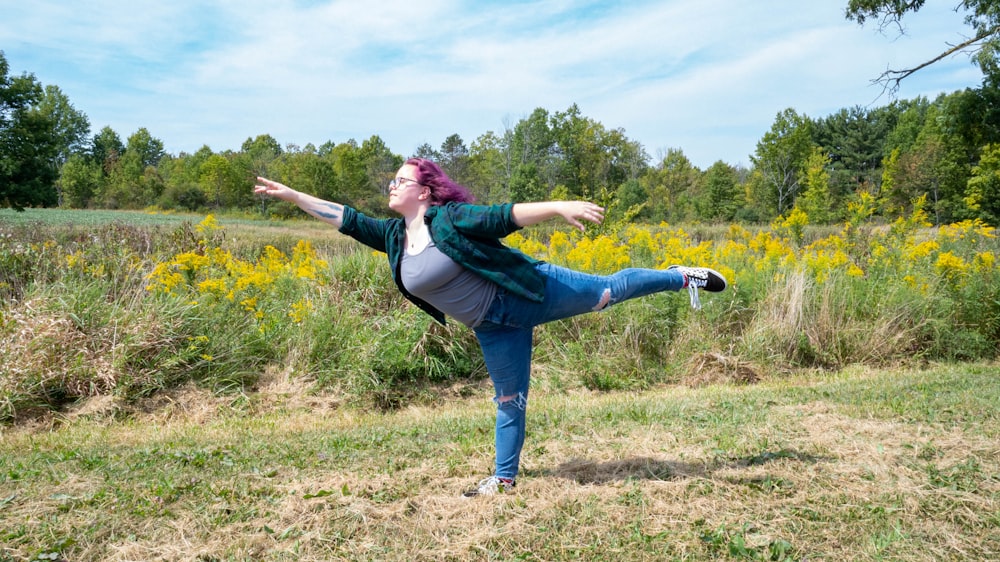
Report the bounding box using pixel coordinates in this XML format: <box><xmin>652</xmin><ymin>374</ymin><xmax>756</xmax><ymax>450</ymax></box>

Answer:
<box><xmin>0</xmin><ymin>51</ymin><xmax>1000</xmax><ymax>225</ymax></box>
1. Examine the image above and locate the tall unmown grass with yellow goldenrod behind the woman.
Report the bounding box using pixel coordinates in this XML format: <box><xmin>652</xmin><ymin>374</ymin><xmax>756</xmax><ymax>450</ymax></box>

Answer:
<box><xmin>0</xmin><ymin>208</ymin><xmax>1000</xmax><ymax>421</ymax></box>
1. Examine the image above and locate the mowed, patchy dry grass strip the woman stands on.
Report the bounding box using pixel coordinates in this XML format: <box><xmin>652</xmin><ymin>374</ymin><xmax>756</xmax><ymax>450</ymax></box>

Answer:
<box><xmin>0</xmin><ymin>364</ymin><xmax>1000</xmax><ymax>561</ymax></box>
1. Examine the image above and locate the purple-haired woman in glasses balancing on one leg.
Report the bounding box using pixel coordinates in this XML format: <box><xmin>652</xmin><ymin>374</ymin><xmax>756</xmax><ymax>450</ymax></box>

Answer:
<box><xmin>254</xmin><ymin>158</ymin><xmax>726</xmax><ymax>497</ymax></box>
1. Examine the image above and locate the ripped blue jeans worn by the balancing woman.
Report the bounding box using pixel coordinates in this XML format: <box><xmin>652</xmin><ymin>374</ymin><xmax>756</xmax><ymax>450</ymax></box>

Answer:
<box><xmin>474</xmin><ymin>263</ymin><xmax>684</xmax><ymax>478</ymax></box>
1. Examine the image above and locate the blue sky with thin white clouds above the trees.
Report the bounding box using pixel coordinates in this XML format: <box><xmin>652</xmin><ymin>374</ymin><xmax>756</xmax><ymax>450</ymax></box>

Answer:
<box><xmin>0</xmin><ymin>0</ymin><xmax>982</xmax><ymax>169</ymax></box>
